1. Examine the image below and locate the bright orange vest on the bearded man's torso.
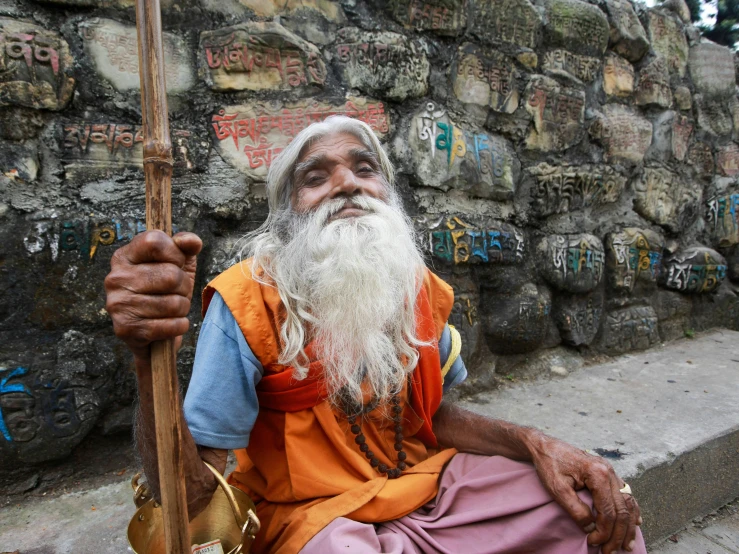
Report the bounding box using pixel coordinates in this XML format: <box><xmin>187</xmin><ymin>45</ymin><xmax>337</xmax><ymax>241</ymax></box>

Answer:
<box><xmin>203</xmin><ymin>260</ymin><xmax>456</xmax><ymax>554</ymax></box>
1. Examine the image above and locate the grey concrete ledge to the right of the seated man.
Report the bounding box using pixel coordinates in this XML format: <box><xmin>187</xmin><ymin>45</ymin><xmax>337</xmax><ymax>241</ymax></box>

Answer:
<box><xmin>462</xmin><ymin>330</ymin><xmax>739</xmax><ymax>542</ymax></box>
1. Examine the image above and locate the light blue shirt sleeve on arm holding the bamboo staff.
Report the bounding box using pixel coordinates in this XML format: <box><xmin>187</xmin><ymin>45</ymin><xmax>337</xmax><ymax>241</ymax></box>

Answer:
<box><xmin>184</xmin><ymin>293</ymin><xmax>264</xmax><ymax>450</ymax></box>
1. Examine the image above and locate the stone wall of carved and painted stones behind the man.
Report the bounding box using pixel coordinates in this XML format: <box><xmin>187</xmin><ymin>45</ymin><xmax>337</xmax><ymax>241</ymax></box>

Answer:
<box><xmin>0</xmin><ymin>0</ymin><xmax>739</xmax><ymax>467</ymax></box>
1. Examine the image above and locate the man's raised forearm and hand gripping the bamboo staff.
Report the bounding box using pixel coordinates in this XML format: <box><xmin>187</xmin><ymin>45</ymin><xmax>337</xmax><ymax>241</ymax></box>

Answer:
<box><xmin>105</xmin><ymin>231</ymin><xmax>226</xmax><ymax>519</ymax></box>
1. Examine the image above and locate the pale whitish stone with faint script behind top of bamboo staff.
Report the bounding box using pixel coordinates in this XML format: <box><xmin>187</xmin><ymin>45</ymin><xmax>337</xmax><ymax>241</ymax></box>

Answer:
<box><xmin>79</xmin><ymin>17</ymin><xmax>195</xmax><ymax>93</ymax></box>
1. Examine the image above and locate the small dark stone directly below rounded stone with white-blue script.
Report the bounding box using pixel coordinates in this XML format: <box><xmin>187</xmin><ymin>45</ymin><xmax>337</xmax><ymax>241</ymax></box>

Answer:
<box><xmin>552</xmin><ymin>293</ymin><xmax>603</xmax><ymax>346</ymax></box>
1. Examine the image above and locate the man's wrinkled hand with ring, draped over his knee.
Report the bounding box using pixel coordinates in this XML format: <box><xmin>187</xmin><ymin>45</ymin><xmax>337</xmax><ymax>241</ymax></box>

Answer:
<box><xmin>532</xmin><ymin>437</ymin><xmax>641</xmax><ymax>554</ymax></box>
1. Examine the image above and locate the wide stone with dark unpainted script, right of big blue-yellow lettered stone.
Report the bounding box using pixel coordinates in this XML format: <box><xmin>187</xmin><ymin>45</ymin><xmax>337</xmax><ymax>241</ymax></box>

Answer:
<box><xmin>527</xmin><ymin>163</ymin><xmax>626</xmax><ymax>216</ymax></box>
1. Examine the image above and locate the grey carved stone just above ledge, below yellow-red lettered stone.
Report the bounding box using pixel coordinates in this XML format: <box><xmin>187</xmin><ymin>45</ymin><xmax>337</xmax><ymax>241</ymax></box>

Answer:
<box><xmin>603</xmin><ymin>306</ymin><xmax>660</xmax><ymax>354</ymax></box>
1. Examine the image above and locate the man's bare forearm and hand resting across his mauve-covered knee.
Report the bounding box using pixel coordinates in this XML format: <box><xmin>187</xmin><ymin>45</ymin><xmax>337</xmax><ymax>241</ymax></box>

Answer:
<box><xmin>432</xmin><ymin>402</ymin><xmax>641</xmax><ymax>554</ymax></box>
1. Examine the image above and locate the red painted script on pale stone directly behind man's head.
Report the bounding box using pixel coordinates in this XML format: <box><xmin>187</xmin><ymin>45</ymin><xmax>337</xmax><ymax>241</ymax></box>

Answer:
<box><xmin>211</xmin><ymin>97</ymin><xmax>390</xmax><ymax>180</ymax></box>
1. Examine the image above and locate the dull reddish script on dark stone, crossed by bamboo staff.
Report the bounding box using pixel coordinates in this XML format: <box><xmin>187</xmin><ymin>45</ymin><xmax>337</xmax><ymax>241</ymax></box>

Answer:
<box><xmin>59</xmin><ymin>122</ymin><xmax>194</xmax><ymax>169</ymax></box>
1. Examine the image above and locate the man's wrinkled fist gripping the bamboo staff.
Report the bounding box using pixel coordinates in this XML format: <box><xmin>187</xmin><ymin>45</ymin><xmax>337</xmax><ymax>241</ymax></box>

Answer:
<box><xmin>105</xmin><ymin>231</ymin><xmax>203</xmax><ymax>361</ymax></box>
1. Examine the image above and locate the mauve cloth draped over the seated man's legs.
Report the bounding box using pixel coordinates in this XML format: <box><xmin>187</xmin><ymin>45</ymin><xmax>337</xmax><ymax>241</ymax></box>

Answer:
<box><xmin>300</xmin><ymin>454</ymin><xmax>647</xmax><ymax>554</ymax></box>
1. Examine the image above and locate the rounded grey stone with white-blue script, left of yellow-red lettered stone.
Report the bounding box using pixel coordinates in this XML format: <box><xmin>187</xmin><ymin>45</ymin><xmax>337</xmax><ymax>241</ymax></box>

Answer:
<box><xmin>537</xmin><ymin>234</ymin><xmax>606</xmax><ymax>293</ymax></box>
